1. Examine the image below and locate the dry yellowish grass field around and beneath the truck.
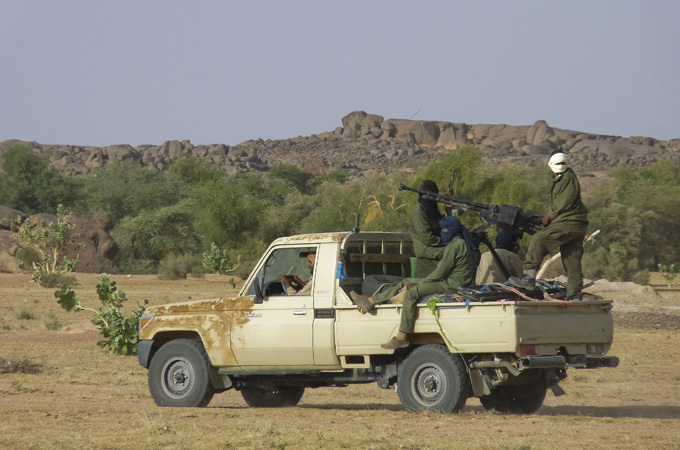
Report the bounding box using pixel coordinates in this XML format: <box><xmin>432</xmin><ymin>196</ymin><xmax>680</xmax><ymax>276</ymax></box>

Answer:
<box><xmin>0</xmin><ymin>274</ymin><xmax>680</xmax><ymax>449</ymax></box>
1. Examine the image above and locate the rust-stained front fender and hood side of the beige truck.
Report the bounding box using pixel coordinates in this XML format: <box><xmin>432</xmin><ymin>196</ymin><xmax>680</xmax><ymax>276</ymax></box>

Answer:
<box><xmin>139</xmin><ymin>297</ymin><xmax>253</xmax><ymax>367</ymax></box>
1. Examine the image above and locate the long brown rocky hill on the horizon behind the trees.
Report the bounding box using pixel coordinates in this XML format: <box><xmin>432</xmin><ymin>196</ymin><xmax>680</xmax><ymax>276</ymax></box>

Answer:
<box><xmin>0</xmin><ymin>111</ymin><xmax>680</xmax><ymax>176</ymax></box>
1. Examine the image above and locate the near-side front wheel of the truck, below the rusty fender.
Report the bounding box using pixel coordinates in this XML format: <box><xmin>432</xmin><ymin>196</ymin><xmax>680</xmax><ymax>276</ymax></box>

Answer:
<box><xmin>149</xmin><ymin>339</ymin><xmax>215</xmax><ymax>407</ymax></box>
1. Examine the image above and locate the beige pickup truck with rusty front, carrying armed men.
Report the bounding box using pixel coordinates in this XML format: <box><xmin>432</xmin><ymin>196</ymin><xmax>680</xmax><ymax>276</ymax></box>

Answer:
<box><xmin>137</xmin><ymin>232</ymin><xmax>618</xmax><ymax>414</ymax></box>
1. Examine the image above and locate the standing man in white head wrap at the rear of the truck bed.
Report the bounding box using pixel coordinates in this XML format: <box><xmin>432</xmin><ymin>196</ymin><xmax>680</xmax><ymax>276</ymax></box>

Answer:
<box><xmin>510</xmin><ymin>151</ymin><xmax>588</xmax><ymax>300</ymax></box>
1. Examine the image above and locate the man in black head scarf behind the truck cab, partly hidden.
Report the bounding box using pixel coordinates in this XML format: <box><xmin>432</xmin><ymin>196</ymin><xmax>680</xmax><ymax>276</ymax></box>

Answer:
<box><xmin>408</xmin><ymin>180</ymin><xmax>445</xmax><ymax>278</ymax></box>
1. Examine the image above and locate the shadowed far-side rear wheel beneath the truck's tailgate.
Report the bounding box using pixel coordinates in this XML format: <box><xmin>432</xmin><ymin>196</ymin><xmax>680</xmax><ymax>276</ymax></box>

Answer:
<box><xmin>479</xmin><ymin>384</ymin><xmax>548</xmax><ymax>414</ymax></box>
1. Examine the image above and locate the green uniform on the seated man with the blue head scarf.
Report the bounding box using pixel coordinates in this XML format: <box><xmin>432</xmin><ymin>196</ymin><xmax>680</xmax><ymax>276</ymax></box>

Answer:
<box><xmin>372</xmin><ymin>236</ymin><xmax>477</xmax><ymax>333</ymax></box>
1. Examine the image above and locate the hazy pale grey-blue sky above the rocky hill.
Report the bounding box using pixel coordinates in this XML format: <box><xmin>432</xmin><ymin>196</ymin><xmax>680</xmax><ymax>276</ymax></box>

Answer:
<box><xmin>0</xmin><ymin>0</ymin><xmax>680</xmax><ymax>146</ymax></box>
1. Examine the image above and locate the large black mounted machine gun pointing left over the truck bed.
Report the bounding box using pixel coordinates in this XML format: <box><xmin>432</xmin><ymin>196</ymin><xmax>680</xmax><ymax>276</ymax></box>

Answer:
<box><xmin>399</xmin><ymin>183</ymin><xmax>542</xmax><ymax>234</ymax></box>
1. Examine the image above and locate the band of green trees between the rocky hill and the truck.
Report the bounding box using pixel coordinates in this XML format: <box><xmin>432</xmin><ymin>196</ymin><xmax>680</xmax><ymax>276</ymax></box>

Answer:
<box><xmin>0</xmin><ymin>145</ymin><xmax>680</xmax><ymax>281</ymax></box>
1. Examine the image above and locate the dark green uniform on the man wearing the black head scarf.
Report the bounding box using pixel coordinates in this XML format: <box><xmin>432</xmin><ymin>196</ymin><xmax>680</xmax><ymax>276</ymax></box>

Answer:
<box><xmin>408</xmin><ymin>203</ymin><xmax>445</xmax><ymax>278</ymax></box>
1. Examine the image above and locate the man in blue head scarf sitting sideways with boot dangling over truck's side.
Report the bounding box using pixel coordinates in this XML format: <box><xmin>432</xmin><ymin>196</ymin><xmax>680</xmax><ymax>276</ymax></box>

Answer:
<box><xmin>350</xmin><ymin>216</ymin><xmax>479</xmax><ymax>349</ymax></box>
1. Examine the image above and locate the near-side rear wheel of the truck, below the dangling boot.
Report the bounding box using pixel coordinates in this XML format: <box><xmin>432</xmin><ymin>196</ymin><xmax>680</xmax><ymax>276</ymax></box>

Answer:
<box><xmin>397</xmin><ymin>344</ymin><xmax>471</xmax><ymax>413</ymax></box>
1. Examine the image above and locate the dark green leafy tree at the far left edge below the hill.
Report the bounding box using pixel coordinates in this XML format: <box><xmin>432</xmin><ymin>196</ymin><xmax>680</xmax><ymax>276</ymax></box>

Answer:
<box><xmin>0</xmin><ymin>145</ymin><xmax>81</xmax><ymax>214</ymax></box>
